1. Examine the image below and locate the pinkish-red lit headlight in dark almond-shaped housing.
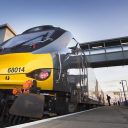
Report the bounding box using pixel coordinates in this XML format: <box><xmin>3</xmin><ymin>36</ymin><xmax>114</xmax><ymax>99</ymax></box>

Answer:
<box><xmin>26</xmin><ymin>69</ymin><xmax>51</xmax><ymax>81</ymax></box>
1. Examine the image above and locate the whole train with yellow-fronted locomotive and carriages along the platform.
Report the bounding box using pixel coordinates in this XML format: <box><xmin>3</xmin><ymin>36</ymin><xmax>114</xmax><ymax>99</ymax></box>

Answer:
<box><xmin>0</xmin><ymin>25</ymin><xmax>104</xmax><ymax>123</ymax></box>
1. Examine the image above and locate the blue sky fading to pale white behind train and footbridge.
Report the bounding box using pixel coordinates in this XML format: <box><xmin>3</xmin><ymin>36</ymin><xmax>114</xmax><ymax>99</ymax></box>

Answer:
<box><xmin>0</xmin><ymin>0</ymin><xmax>128</xmax><ymax>99</ymax></box>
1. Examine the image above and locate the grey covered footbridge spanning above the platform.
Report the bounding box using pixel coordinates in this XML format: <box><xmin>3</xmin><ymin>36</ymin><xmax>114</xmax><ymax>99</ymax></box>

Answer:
<box><xmin>80</xmin><ymin>37</ymin><xmax>128</xmax><ymax>68</ymax></box>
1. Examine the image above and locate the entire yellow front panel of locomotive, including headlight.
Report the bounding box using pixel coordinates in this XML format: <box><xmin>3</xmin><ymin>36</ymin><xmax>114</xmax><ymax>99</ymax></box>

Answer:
<box><xmin>0</xmin><ymin>53</ymin><xmax>53</xmax><ymax>90</ymax></box>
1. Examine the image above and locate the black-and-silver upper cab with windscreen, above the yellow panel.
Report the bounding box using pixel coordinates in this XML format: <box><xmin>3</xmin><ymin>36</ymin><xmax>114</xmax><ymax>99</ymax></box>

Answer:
<box><xmin>0</xmin><ymin>26</ymin><xmax>67</xmax><ymax>54</ymax></box>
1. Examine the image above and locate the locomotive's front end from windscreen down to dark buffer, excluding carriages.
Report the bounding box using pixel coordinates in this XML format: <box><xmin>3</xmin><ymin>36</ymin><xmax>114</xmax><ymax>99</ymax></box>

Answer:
<box><xmin>0</xmin><ymin>25</ymin><xmax>76</xmax><ymax>123</ymax></box>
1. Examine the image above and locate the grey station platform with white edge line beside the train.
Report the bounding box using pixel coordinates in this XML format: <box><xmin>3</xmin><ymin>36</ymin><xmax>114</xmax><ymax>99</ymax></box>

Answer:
<box><xmin>9</xmin><ymin>106</ymin><xmax>128</xmax><ymax>128</ymax></box>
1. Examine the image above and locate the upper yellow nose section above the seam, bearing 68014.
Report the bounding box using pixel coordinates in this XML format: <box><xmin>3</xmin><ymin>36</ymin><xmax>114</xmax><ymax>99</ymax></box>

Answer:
<box><xmin>0</xmin><ymin>53</ymin><xmax>53</xmax><ymax>74</ymax></box>
